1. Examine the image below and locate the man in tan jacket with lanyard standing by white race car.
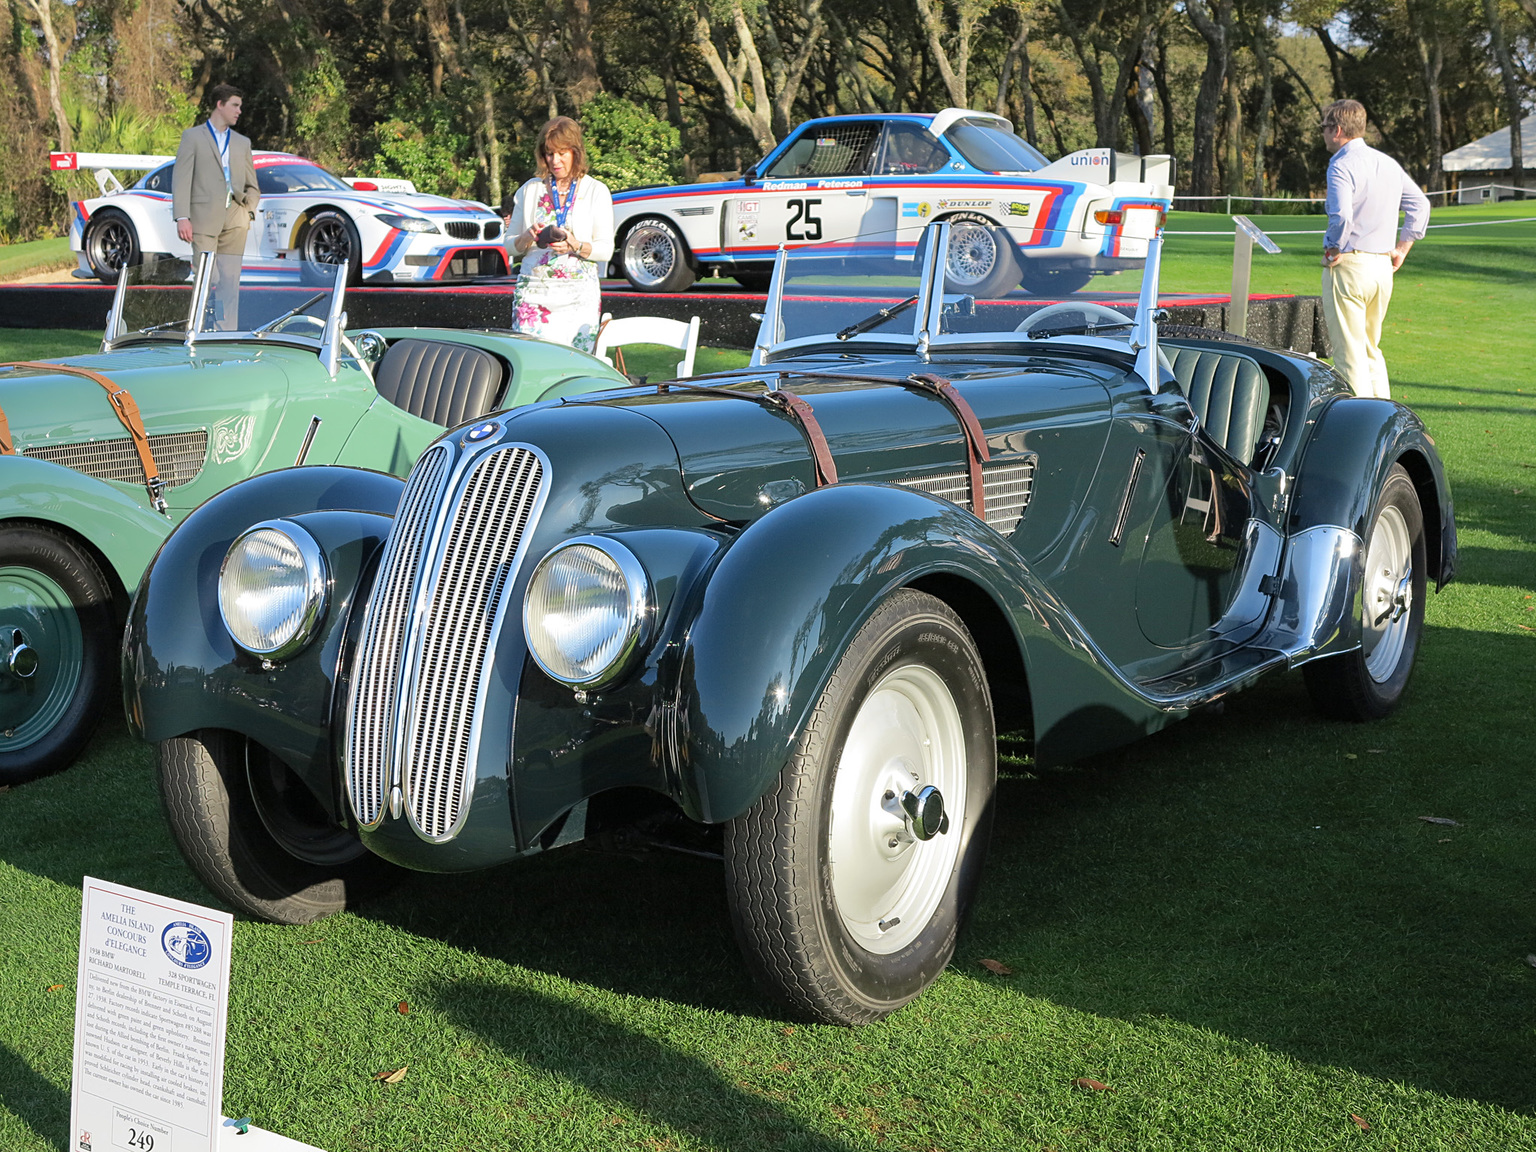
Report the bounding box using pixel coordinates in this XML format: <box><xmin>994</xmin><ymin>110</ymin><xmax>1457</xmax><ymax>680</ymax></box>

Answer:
<box><xmin>170</xmin><ymin>84</ymin><xmax>261</xmax><ymax>332</ymax></box>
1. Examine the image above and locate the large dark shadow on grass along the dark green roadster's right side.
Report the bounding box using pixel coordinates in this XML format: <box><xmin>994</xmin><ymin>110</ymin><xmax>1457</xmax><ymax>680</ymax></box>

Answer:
<box><xmin>955</xmin><ymin>628</ymin><xmax>1536</xmax><ymax>1114</ymax></box>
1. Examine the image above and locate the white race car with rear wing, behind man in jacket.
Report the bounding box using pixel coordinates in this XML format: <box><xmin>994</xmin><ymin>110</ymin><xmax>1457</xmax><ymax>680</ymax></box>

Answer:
<box><xmin>49</xmin><ymin>152</ymin><xmax>507</xmax><ymax>284</ymax></box>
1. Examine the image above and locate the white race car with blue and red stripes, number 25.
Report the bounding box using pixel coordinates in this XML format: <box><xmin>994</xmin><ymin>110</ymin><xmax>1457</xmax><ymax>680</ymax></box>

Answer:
<box><xmin>613</xmin><ymin>108</ymin><xmax>1174</xmax><ymax>296</ymax></box>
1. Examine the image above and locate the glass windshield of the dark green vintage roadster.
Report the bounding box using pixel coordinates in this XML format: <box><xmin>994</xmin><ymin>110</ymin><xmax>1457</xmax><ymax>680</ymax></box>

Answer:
<box><xmin>757</xmin><ymin>206</ymin><xmax>1161</xmax><ymax>362</ymax></box>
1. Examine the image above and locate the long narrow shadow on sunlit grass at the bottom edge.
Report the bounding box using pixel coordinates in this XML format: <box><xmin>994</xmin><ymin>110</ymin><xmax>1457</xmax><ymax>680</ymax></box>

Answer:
<box><xmin>427</xmin><ymin>980</ymin><xmax>848</xmax><ymax>1152</ymax></box>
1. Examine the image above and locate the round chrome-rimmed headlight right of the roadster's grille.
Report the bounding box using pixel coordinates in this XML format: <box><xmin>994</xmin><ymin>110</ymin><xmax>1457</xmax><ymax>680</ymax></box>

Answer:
<box><xmin>522</xmin><ymin>536</ymin><xmax>653</xmax><ymax>685</ymax></box>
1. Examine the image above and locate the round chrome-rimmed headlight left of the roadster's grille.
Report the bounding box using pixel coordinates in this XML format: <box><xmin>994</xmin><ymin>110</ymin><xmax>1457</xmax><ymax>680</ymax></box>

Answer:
<box><xmin>218</xmin><ymin>521</ymin><xmax>330</xmax><ymax>659</ymax></box>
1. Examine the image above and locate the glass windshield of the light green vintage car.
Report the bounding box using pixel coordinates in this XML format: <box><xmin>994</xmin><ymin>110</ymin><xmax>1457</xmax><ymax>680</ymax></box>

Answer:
<box><xmin>108</xmin><ymin>257</ymin><xmax>346</xmax><ymax>344</ymax></box>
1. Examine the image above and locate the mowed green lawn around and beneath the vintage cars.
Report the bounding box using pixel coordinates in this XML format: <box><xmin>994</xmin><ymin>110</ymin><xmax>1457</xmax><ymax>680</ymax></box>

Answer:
<box><xmin>0</xmin><ymin>204</ymin><xmax>1536</xmax><ymax>1152</ymax></box>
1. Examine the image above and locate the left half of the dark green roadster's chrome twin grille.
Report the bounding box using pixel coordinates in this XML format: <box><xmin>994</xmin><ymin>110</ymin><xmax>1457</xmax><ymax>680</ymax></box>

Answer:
<box><xmin>347</xmin><ymin>447</ymin><xmax>449</xmax><ymax>825</ymax></box>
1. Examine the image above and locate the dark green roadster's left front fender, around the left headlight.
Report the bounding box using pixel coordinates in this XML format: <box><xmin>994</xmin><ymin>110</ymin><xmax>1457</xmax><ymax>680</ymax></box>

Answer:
<box><xmin>123</xmin><ymin>467</ymin><xmax>404</xmax><ymax>786</ymax></box>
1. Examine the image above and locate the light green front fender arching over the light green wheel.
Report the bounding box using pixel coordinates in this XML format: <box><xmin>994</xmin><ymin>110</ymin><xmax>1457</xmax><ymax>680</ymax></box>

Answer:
<box><xmin>0</xmin><ymin>456</ymin><xmax>172</xmax><ymax>588</ymax></box>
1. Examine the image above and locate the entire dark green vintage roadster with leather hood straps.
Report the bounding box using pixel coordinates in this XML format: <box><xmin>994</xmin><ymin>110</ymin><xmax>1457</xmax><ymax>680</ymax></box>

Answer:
<box><xmin>124</xmin><ymin>225</ymin><xmax>1456</xmax><ymax>1025</ymax></box>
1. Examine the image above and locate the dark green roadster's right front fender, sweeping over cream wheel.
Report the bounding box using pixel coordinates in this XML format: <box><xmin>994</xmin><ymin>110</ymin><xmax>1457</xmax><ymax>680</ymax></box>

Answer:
<box><xmin>674</xmin><ymin>484</ymin><xmax>1169</xmax><ymax>822</ymax></box>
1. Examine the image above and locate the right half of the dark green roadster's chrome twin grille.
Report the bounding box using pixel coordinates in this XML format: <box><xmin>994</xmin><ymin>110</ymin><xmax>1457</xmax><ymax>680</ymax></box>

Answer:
<box><xmin>401</xmin><ymin>447</ymin><xmax>542</xmax><ymax>839</ymax></box>
